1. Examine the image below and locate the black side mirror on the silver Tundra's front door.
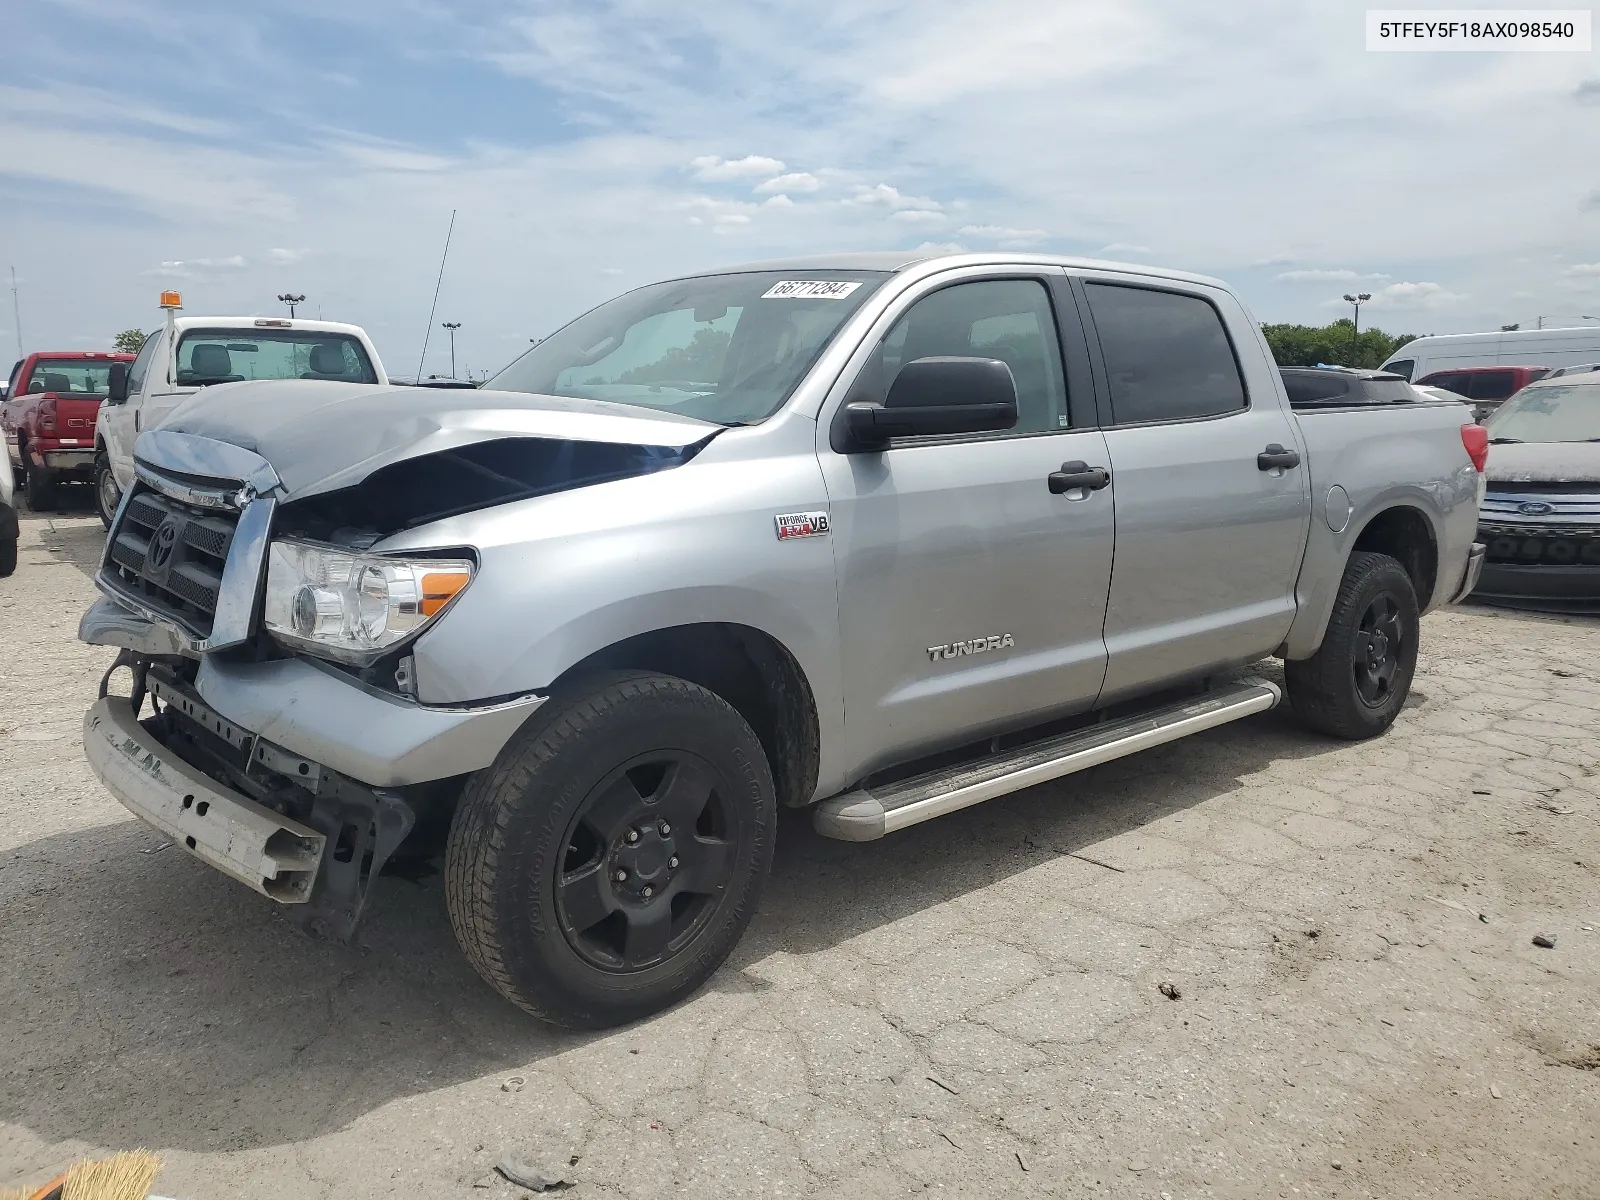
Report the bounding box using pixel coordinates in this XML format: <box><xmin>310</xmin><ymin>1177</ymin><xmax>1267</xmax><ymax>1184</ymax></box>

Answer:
<box><xmin>845</xmin><ymin>357</ymin><xmax>1018</xmax><ymax>451</ymax></box>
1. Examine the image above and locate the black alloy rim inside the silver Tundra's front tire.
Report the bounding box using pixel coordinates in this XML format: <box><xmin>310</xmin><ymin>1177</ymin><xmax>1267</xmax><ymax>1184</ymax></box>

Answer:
<box><xmin>555</xmin><ymin>750</ymin><xmax>738</xmax><ymax>971</ymax></box>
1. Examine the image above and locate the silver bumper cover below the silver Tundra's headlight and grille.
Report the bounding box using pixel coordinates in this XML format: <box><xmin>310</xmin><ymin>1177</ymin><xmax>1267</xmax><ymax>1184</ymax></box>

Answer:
<box><xmin>78</xmin><ymin>598</ymin><xmax>546</xmax><ymax>787</ymax></box>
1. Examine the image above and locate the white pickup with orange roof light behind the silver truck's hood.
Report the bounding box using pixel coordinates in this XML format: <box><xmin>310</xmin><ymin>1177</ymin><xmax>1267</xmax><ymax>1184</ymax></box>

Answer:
<box><xmin>94</xmin><ymin>317</ymin><xmax>389</xmax><ymax>530</ymax></box>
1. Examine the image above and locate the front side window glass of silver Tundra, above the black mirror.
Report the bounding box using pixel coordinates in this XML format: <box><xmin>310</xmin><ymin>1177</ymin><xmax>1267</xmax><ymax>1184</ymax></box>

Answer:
<box><xmin>851</xmin><ymin>280</ymin><xmax>1067</xmax><ymax>434</ymax></box>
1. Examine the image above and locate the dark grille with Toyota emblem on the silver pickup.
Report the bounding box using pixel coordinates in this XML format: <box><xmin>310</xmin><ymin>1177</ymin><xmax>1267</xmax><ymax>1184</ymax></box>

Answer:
<box><xmin>109</xmin><ymin>483</ymin><xmax>238</xmax><ymax>637</ymax></box>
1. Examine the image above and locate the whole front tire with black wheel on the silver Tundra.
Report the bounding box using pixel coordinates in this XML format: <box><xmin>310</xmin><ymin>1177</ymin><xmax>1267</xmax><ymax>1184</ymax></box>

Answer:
<box><xmin>445</xmin><ymin>672</ymin><xmax>778</xmax><ymax>1029</ymax></box>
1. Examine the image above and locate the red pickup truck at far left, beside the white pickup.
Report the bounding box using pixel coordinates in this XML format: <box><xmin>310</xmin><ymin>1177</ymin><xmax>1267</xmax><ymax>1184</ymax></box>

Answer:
<box><xmin>0</xmin><ymin>350</ymin><xmax>133</xmax><ymax>512</ymax></box>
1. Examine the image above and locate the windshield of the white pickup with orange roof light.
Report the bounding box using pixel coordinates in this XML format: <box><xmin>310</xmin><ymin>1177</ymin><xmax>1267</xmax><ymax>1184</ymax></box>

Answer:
<box><xmin>176</xmin><ymin>330</ymin><xmax>378</xmax><ymax>387</ymax></box>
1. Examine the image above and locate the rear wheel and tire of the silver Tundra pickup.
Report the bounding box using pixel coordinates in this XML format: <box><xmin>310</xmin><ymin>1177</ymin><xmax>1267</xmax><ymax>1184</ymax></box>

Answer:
<box><xmin>1283</xmin><ymin>550</ymin><xmax>1421</xmax><ymax>741</ymax></box>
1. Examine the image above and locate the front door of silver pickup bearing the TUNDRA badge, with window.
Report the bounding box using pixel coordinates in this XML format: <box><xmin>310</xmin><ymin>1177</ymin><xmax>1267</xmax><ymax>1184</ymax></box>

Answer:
<box><xmin>818</xmin><ymin>267</ymin><xmax>1112</xmax><ymax>773</ymax></box>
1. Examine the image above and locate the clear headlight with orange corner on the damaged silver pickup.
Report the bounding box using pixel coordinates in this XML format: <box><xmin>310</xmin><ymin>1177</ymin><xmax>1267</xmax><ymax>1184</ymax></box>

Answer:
<box><xmin>266</xmin><ymin>541</ymin><xmax>472</xmax><ymax>664</ymax></box>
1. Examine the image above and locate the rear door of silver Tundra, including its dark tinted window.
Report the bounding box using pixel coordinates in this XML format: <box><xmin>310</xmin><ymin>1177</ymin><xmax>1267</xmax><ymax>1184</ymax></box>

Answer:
<box><xmin>1078</xmin><ymin>277</ymin><xmax>1310</xmax><ymax>702</ymax></box>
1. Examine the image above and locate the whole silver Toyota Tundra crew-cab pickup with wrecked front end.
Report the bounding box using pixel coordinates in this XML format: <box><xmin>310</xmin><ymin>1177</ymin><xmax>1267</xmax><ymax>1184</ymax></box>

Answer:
<box><xmin>80</xmin><ymin>254</ymin><xmax>1485</xmax><ymax>1027</ymax></box>
